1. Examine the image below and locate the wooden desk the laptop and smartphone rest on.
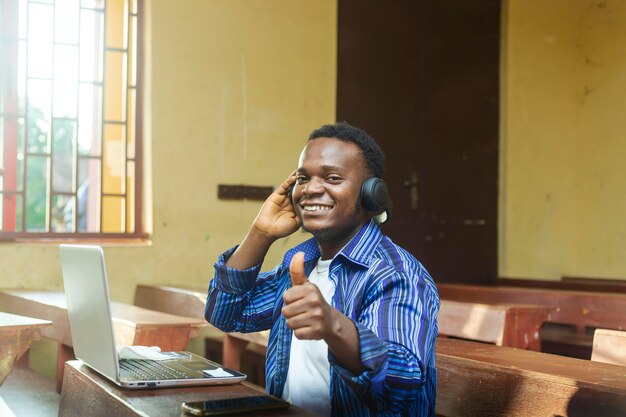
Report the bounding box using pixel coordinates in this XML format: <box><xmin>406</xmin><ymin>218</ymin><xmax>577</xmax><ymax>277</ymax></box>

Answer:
<box><xmin>59</xmin><ymin>361</ymin><xmax>312</xmax><ymax>417</ymax></box>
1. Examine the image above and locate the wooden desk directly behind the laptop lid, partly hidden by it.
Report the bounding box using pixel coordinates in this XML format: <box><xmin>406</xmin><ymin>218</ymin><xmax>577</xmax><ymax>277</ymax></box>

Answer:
<box><xmin>0</xmin><ymin>290</ymin><xmax>206</xmax><ymax>390</ymax></box>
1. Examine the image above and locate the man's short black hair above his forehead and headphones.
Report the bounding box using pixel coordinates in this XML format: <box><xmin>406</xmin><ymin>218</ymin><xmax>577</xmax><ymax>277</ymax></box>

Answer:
<box><xmin>309</xmin><ymin>122</ymin><xmax>385</xmax><ymax>178</ymax></box>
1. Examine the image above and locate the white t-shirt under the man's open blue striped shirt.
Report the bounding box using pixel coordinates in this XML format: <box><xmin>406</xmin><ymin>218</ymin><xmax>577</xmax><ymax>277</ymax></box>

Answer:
<box><xmin>283</xmin><ymin>259</ymin><xmax>335</xmax><ymax>417</ymax></box>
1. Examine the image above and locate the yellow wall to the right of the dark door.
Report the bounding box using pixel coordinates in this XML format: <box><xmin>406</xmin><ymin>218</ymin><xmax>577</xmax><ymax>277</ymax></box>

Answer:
<box><xmin>499</xmin><ymin>0</ymin><xmax>626</xmax><ymax>279</ymax></box>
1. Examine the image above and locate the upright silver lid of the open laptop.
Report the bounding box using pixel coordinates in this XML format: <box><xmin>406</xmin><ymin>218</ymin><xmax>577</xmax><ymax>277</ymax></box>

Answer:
<box><xmin>60</xmin><ymin>245</ymin><xmax>119</xmax><ymax>382</ymax></box>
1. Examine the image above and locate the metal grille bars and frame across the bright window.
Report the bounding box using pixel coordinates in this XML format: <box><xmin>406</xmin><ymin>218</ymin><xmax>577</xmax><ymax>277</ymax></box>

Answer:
<box><xmin>0</xmin><ymin>0</ymin><xmax>146</xmax><ymax>240</ymax></box>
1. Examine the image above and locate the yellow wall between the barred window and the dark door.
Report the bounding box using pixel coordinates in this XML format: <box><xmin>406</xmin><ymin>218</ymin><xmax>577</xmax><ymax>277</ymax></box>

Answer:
<box><xmin>0</xmin><ymin>0</ymin><xmax>337</xmax><ymax>302</ymax></box>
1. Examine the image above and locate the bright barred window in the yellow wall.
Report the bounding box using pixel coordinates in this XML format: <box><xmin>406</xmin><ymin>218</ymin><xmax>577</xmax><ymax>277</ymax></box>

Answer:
<box><xmin>0</xmin><ymin>0</ymin><xmax>143</xmax><ymax>240</ymax></box>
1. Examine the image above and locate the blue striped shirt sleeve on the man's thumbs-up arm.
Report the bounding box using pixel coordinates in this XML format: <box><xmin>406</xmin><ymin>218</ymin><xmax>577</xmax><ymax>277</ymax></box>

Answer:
<box><xmin>329</xmin><ymin>272</ymin><xmax>439</xmax><ymax>413</ymax></box>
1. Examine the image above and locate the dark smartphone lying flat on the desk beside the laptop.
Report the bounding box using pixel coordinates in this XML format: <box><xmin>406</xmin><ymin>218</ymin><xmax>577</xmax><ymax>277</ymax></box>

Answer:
<box><xmin>182</xmin><ymin>395</ymin><xmax>290</xmax><ymax>416</ymax></box>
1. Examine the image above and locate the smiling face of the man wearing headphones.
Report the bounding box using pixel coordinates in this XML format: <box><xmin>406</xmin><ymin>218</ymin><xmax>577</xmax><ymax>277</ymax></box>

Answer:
<box><xmin>293</xmin><ymin>138</ymin><xmax>369</xmax><ymax>243</ymax></box>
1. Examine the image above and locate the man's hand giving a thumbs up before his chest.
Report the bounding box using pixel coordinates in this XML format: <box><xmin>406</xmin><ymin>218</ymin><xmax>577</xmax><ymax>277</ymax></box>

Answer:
<box><xmin>282</xmin><ymin>252</ymin><xmax>337</xmax><ymax>340</ymax></box>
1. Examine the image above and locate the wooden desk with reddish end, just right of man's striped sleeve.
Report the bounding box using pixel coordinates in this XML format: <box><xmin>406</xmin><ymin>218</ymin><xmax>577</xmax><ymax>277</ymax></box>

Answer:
<box><xmin>437</xmin><ymin>300</ymin><xmax>554</xmax><ymax>351</ymax></box>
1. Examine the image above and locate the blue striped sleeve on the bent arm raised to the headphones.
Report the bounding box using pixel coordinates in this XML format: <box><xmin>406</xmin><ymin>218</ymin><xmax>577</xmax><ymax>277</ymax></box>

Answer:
<box><xmin>204</xmin><ymin>246</ymin><xmax>281</xmax><ymax>333</ymax></box>
